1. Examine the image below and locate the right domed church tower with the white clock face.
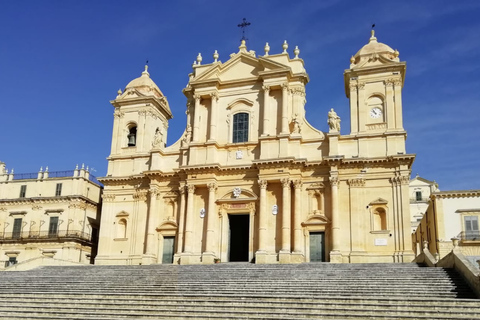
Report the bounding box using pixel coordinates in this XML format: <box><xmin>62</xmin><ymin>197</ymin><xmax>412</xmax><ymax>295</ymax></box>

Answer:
<box><xmin>344</xmin><ymin>30</ymin><xmax>406</xmax><ymax>138</ymax></box>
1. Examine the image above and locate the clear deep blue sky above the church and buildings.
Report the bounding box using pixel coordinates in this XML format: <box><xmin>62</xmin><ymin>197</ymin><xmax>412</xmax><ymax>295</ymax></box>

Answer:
<box><xmin>0</xmin><ymin>0</ymin><xmax>480</xmax><ymax>190</ymax></box>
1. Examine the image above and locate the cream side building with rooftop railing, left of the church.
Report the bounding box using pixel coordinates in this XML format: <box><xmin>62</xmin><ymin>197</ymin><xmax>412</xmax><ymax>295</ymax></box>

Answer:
<box><xmin>0</xmin><ymin>162</ymin><xmax>102</xmax><ymax>269</ymax></box>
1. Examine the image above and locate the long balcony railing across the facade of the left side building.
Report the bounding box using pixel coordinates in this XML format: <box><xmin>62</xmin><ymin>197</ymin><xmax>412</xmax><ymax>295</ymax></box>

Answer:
<box><xmin>0</xmin><ymin>230</ymin><xmax>91</xmax><ymax>243</ymax></box>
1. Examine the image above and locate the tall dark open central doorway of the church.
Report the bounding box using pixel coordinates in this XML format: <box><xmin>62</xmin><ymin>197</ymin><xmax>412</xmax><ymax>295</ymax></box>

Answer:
<box><xmin>228</xmin><ymin>214</ymin><xmax>250</xmax><ymax>261</ymax></box>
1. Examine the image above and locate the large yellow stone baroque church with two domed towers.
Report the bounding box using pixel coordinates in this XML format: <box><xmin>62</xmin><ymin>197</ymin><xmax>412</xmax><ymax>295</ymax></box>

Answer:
<box><xmin>96</xmin><ymin>31</ymin><xmax>415</xmax><ymax>264</ymax></box>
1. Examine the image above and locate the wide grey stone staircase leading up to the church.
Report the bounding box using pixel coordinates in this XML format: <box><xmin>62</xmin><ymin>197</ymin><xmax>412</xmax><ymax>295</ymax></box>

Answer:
<box><xmin>0</xmin><ymin>263</ymin><xmax>480</xmax><ymax>320</ymax></box>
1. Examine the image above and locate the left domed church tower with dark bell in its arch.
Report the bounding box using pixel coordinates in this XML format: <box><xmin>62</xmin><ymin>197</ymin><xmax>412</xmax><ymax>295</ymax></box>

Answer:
<box><xmin>108</xmin><ymin>66</ymin><xmax>172</xmax><ymax>176</ymax></box>
